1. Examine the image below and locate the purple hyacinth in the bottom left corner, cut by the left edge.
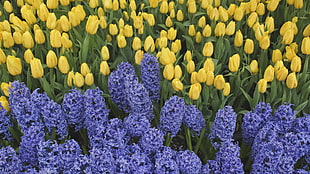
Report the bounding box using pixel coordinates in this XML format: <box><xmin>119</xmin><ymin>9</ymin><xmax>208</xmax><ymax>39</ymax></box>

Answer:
<box><xmin>0</xmin><ymin>146</ymin><xmax>22</xmax><ymax>174</ymax></box>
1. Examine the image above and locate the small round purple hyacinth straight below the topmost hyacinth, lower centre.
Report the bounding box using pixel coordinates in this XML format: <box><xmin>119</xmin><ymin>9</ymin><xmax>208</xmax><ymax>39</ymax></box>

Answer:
<box><xmin>139</xmin><ymin>128</ymin><xmax>165</xmax><ymax>154</ymax></box>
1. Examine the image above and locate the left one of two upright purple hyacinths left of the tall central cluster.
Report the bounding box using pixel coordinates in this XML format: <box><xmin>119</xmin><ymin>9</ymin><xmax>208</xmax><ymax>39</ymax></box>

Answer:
<box><xmin>61</xmin><ymin>89</ymin><xmax>85</xmax><ymax>131</ymax></box>
